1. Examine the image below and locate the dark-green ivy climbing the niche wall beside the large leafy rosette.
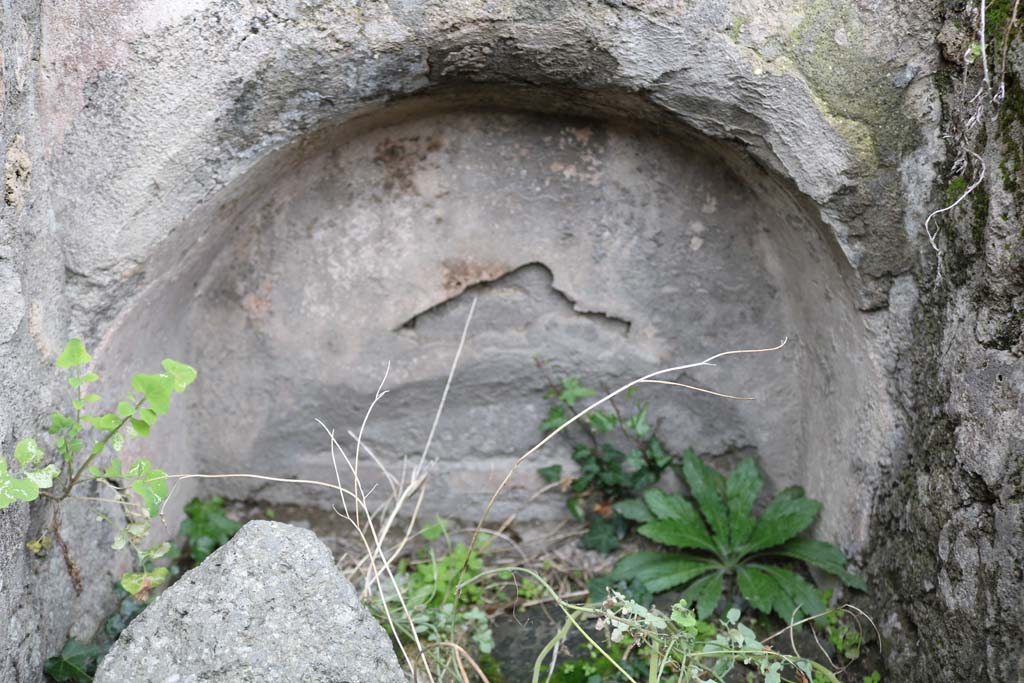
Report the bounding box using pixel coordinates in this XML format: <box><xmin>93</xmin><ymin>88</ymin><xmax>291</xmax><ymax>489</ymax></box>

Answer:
<box><xmin>538</xmin><ymin>378</ymin><xmax>674</xmax><ymax>553</ymax></box>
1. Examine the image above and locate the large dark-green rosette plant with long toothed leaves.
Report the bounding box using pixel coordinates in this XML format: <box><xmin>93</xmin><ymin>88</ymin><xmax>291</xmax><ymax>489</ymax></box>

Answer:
<box><xmin>611</xmin><ymin>451</ymin><xmax>866</xmax><ymax>623</ymax></box>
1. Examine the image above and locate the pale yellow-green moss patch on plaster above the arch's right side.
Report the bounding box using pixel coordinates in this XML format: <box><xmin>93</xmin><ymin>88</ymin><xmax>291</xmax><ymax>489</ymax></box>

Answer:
<box><xmin>786</xmin><ymin>0</ymin><xmax>920</xmax><ymax>164</ymax></box>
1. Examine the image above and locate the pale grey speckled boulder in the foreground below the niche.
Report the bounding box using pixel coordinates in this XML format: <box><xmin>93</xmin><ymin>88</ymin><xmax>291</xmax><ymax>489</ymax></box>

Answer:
<box><xmin>96</xmin><ymin>521</ymin><xmax>406</xmax><ymax>683</ymax></box>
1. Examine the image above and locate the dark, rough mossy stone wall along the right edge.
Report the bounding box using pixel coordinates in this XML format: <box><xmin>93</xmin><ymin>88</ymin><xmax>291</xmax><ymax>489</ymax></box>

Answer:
<box><xmin>869</xmin><ymin>0</ymin><xmax>1024</xmax><ymax>682</ymax></box>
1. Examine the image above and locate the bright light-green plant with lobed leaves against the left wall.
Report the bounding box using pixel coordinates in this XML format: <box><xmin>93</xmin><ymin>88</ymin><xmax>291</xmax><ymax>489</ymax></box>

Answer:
<box><xmin>0</xmin><ymin>339</ymin><xmax>196</xmax><ymax>596</ymax></box>
